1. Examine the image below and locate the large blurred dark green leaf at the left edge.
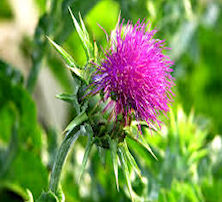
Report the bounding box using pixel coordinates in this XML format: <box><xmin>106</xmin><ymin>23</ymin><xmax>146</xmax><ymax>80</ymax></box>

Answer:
<box><xmin>0</xmin><ymin>62</ymin><xmax>48</xmax><ymax>197</ymax></box>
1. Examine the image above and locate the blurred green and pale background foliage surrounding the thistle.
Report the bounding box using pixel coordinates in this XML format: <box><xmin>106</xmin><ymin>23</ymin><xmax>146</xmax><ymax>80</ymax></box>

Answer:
<box><xmin>0</xmin><ymin>0</ymin><xmax>222</xmax><ymax>202</ymax></box>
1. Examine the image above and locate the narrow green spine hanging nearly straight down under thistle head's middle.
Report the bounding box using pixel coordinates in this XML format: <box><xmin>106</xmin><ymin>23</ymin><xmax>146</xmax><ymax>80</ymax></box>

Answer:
<box><xmin>109</xmin><ymin>138</ymin><xmax>119</xmax><ymax>191</ymax></box>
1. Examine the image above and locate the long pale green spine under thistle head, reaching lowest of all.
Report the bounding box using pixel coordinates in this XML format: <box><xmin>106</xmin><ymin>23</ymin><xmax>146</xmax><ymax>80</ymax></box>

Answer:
<box><xmin>118</xmin><ymin>149</ymin><xmax>134</xmax><ymax>201</ymax></box>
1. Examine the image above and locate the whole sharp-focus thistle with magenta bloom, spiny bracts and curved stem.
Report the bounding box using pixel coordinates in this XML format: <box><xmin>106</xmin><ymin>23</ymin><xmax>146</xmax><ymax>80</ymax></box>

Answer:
<box><xmin>39</xmin><ymin>10</ymin><xmax>174</xmax><ymax>201</ymax></box>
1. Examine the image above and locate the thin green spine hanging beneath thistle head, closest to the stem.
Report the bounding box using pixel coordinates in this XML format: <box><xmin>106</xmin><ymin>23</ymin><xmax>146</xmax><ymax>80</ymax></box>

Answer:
<box><xmin>79</xmin><ymin>125</ymin><xmax>94</xmax><ymax>182</ymax></box>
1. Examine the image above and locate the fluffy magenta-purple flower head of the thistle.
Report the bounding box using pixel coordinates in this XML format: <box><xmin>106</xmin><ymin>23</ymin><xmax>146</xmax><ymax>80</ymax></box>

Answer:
<box><xmin>90</xmin><ymin>20</ymin><xmax>174</xmax><ymax>127</ymax></box>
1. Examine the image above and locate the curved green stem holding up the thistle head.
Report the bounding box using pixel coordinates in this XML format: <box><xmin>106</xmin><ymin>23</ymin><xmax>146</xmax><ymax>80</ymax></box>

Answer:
<box><xmin>49</xmin><ymin>113</ymin><xmax>88</xmax><ymax>193</ymax></box>
